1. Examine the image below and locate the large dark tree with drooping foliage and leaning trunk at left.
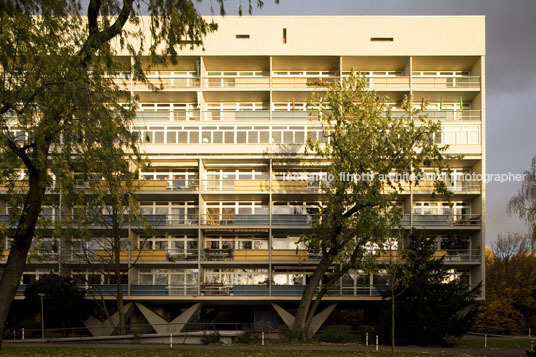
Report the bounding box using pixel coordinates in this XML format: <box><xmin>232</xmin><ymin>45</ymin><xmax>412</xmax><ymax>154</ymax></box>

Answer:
<box><xmin>0</xmin><ymin>0</ymin><xmax>272</xmax><ymax>342</ymax></box>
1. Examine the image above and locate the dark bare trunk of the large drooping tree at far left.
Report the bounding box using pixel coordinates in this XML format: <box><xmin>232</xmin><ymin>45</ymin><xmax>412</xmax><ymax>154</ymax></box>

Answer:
<box><xmin>0</xmin><ymin>172</ymin><xmax>46</xmax><ymax>348</ymax></box>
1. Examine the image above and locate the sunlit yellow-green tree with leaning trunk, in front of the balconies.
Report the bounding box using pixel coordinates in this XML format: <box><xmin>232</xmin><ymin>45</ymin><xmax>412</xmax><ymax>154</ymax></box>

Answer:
<box><xmin>292</xmin><ymin>74</ymin><xmax>443</xmax><ymax>339</ymax></box>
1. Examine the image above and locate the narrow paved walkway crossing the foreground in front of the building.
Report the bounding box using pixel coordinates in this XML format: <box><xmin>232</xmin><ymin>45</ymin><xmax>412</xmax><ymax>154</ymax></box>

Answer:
<box><xmin>4</xmin><ymin>341</ymin><xmax>526</xmax><ymax>356</ymax></box>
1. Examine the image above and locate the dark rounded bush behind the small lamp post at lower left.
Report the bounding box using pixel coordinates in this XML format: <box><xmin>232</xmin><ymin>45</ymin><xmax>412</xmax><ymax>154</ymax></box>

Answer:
<box><xmin>24</xmin><ymin>274</ymin><xmax>88</xmax><ymax>328</ymax></box>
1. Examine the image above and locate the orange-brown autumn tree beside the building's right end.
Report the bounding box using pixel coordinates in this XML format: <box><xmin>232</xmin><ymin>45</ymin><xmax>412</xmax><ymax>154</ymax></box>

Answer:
<box><xmin>477</xmin><ymin>235</ymin><xmax>536</xmax><ymax>331</ymax></box>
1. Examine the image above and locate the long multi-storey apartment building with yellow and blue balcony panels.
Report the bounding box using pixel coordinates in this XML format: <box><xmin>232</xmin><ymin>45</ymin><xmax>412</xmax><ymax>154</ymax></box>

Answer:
<box><xmin>0</xmin><ymin>16</ymin><xmax>485</xmax><ymax>334</ymax></box>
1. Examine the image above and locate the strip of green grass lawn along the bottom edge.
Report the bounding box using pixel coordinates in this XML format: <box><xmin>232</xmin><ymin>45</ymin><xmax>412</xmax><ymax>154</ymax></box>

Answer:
<box><xmin>0</xmin><ymin>346</ymin><xmax>478</xmax><ymax>357</ymax></box>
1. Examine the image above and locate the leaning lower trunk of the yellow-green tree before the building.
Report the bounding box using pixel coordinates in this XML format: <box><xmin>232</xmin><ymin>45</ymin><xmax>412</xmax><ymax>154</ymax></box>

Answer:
<box><xmin>292</xmin><ymin>254</ymin><xmax>331</xmax><ymax>340</ymax></box>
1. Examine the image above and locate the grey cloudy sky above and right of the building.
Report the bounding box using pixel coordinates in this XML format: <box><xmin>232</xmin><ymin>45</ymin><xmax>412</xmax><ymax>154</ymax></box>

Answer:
<box><xmin>197</xmin><ymin>0</ymin><xmax>536</xmax><ymax>245</ymax></box>
